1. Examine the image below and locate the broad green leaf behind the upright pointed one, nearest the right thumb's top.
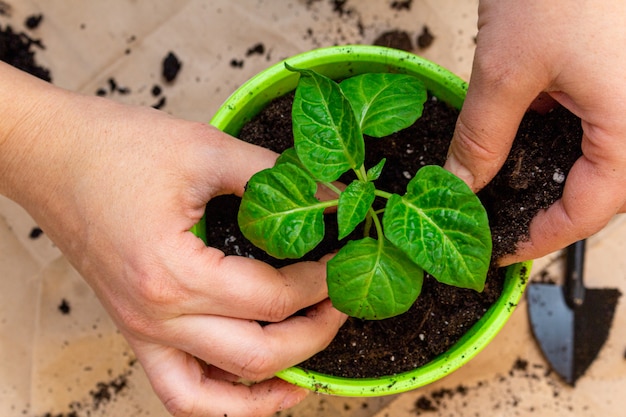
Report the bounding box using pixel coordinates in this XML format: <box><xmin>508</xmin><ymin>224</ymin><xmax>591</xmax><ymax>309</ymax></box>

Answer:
<box><xmin>340</xmin><ymin>73</ymin><xmax>428</xmax><ymax>138</ymax></box>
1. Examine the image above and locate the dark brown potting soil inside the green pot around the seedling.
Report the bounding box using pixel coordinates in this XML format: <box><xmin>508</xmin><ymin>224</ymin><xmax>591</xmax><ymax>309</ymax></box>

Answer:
<box><xmin>206</xmin><ymin>88</ymin><xmax>582</xmax><ymax>377</ymax></box>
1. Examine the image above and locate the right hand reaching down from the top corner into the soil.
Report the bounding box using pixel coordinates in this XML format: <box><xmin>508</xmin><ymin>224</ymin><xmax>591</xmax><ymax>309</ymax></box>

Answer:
<box><xmin>445</xmin><ymin>0</ymin><xmax>626</xmax><ymax>265</ymax></box>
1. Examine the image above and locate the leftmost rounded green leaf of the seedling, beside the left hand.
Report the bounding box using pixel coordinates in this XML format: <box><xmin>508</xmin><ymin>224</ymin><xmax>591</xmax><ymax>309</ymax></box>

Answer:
<box><xmin>237</xmin><ymin>163</ymin><xmax>327</xmax><ymax>259</ymax></box>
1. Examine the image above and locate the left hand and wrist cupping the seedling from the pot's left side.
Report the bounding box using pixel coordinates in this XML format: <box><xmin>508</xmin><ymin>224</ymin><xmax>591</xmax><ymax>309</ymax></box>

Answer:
<box><xmin>0</xmin><ymin>62</ymin><xmax>344</xmax><ymax>417</ymax></box>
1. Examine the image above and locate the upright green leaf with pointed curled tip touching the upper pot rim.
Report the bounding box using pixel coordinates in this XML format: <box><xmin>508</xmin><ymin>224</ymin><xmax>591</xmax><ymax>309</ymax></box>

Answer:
<box><xmin>286</xmin><ymin>65</ymin><xmax>365</xmax><ymax>182</ymax></box>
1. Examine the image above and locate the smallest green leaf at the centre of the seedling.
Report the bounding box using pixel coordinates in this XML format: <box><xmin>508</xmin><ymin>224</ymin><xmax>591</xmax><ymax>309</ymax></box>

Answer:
<box><xmin>337</xmin><ymin>180</ymin><xmax>376</xmax><ymax>239</ymax></box>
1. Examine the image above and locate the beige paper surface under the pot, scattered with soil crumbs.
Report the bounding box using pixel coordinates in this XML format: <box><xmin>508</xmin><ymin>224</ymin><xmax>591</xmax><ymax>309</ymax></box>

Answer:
<box><xmin>0</xmin><ymin>0</ymin><xmax>626</xmax><ymax>417</ymax></box>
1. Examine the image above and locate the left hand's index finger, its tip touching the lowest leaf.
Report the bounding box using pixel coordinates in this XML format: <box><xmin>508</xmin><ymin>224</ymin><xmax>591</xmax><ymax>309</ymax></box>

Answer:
<box><xmin>173</xmin><ymin>242</ymin><xmax>328</xmax><ymax>322</ymax></box>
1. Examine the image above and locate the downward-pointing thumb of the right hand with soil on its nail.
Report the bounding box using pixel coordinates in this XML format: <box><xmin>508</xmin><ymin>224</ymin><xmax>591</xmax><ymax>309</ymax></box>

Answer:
<box><xmin>445</xmin><ymin>40</ymin><xmax>547</xmax><ymax>191</ymax></box>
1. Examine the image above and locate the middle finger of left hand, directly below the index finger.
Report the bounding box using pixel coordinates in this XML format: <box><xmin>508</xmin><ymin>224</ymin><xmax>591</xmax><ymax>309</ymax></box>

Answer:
<box><xmin>162</xmin><ymin>300</ymin><xmax>346</xmax><ymax>381</ymax></box>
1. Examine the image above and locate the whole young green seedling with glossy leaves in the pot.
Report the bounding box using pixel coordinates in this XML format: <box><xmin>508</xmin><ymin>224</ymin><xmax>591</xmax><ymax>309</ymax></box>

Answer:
<box><xmin>238</xmin><ymin>65</ymin><xmax>491</xmax><ymax>319</ymax></box>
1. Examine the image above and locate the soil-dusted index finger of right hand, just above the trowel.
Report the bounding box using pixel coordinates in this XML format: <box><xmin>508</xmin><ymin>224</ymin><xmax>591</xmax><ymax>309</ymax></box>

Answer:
<box><xmin>499</xmin><ymin>146</ymin><xmax>626</xmax><ymax>265</ymax></box>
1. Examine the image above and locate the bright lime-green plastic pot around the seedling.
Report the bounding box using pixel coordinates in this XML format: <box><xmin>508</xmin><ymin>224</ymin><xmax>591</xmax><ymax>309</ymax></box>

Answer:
<box><xmin>192</xmin><ymin>45</ymin><xmax>532</xmax><ymax>397</ymax></box>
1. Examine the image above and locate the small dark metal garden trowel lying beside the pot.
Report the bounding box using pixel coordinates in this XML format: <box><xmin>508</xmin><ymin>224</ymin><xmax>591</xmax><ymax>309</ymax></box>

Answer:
<box><xmin>527</xmin><ymin>240</ymin><xmax>621</xmax><ymax>386</ymax></box>
